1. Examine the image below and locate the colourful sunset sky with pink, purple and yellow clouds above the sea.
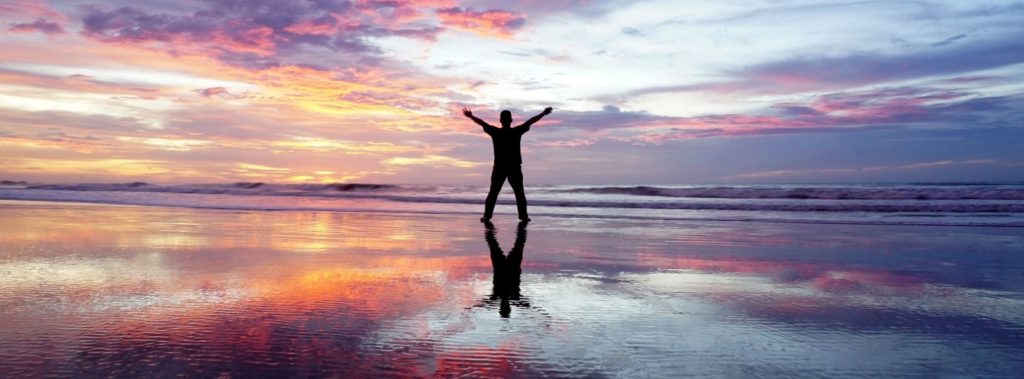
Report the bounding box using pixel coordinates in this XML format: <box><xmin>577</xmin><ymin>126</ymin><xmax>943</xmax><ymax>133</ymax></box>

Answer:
<box><xmin>0</xmin><ymin>0</ymin><xmax>1024</xmax><ymax>184</ymax></box>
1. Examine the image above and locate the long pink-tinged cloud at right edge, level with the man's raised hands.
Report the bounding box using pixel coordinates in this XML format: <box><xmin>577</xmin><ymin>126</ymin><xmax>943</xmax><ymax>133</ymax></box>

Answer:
<box><xmin>614</xmin><ymin>87</ymin><xmax>1024</xmax><ymax>143</ymax></box>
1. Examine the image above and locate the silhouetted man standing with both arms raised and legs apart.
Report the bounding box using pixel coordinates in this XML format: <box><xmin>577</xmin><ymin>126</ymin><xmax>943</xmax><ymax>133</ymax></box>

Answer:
<box><xmin>462</xmin><ymin>107</ymin><xmax>551</xmax><ymax>222</ymax></box>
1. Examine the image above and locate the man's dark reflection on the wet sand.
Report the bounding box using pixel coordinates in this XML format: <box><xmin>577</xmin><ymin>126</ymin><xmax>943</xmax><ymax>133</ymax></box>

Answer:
<box><xmin>483</xmin><ymin>222</ymin><xmax>529</xmax><ymax>318</ymax></box>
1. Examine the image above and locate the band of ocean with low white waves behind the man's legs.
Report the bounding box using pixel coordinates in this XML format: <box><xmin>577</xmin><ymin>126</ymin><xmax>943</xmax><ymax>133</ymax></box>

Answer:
<box><xmin>0</xmin><ymin>181</ymin><xmax>1024</xmax><ymax>226</ymax></box>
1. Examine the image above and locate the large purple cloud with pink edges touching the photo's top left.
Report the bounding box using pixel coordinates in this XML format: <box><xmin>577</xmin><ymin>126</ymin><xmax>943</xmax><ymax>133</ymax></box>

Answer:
<box><xmin>82</xmin><ymin>0</ymin><xmax>440</xmax><ymax>66</ymax></box>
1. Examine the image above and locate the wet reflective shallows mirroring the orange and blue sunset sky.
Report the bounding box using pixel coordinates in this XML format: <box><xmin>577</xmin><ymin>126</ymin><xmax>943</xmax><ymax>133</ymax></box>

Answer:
<box><xmin>0</xmin><ymin>202</ymin><xmax>1024</xmax><ymax>377</ymax></box>
